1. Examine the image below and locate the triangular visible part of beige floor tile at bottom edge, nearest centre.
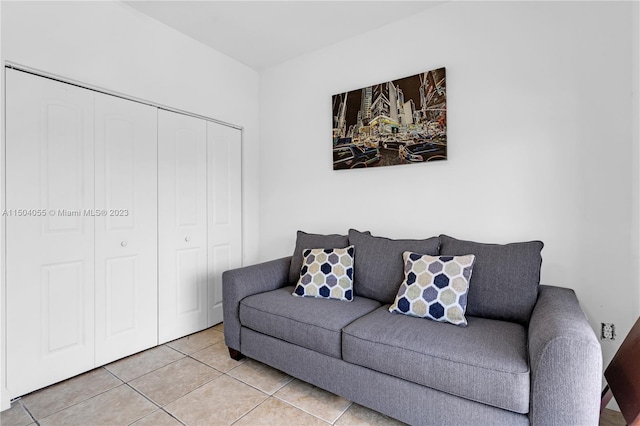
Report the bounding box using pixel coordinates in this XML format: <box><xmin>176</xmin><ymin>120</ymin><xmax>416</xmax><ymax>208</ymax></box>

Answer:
<box><xmin>233</xmin><ymin>397</ymin><xmax>328</xmax><ymax>426</ymax></box>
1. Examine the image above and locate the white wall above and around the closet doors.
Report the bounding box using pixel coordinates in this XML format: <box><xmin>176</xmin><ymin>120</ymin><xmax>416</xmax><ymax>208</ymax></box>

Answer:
<box><xmin>0</xmin><ymin>1</ymin><xmax>259</xmax><ymax>408</ymax></box>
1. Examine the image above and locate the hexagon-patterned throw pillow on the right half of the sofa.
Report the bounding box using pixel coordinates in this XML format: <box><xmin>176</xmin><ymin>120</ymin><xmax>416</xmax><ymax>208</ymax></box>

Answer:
<box><xmin>389</xmin><ymin>251</ymin><xmax>476</xmax><ymax>327</ymax></box>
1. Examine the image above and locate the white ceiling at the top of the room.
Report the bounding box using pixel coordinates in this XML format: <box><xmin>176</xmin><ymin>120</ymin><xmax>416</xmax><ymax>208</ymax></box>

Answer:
<box><xmin>125</xmin><ymin>0</ymin><xmax>444</xmax><ymax>71</ymax></box>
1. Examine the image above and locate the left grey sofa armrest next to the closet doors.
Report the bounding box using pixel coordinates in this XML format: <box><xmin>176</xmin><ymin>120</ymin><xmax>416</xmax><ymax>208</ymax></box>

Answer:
<box><xmin>222</xmin><ymin>256</ymin><xmax>291</xmax><ymax>351</ymax></box>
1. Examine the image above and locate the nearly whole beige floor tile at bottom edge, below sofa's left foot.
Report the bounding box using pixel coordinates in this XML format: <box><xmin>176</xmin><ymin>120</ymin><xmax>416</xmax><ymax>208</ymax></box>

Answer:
<box><xmin>165</xmin><ymin>375</ymin><xmax>268</xmax><ymax>426</ymax></box>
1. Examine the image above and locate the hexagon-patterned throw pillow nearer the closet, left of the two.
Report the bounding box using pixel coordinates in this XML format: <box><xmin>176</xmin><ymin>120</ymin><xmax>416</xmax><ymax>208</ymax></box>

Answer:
<box><xmin>293</xmin><ymin>246</ymin><xmax>354</xmax><ymax>302</ymax></box>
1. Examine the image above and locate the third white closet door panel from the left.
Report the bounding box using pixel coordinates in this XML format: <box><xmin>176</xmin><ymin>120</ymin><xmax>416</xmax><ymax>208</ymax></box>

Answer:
<box><xmin>158</xmin><ymin>110</ymin><xmax>207</xmax><ymax>343</ymax></box>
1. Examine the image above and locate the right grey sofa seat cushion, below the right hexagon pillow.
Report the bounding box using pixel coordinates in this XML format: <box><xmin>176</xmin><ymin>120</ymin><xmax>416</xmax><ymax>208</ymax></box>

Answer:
<box><xmin>342</xmin><ymin>306</ymin><xmax>530</xmax><ymax>414</ymax></box>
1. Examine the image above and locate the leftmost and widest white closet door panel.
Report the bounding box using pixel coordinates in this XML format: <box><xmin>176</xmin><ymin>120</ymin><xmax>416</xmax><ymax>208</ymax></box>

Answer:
<box><xmin>6</xmin><ymin>70</ymin><xmax>94</xmax><ymax>396</ymax></box>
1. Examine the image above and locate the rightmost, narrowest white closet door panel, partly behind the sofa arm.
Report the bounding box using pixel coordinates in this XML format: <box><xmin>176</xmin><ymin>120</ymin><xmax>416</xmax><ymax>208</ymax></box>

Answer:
<box><xmin>207</xmin><ymin>122</ymin><xmax>242</xmax><ymax>326</ymax></box>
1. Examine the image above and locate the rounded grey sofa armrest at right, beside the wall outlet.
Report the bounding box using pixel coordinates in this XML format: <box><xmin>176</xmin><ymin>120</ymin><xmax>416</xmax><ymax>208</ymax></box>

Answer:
<box><xmin>528</xmin><ymin>286</ymin><xmax>602</xmax><ymax>425</ymax></box>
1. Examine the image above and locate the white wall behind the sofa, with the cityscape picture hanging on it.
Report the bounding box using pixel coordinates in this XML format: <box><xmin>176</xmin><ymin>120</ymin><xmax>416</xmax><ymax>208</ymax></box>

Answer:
<box><xmin>260</xmin><ymin>2</ymin><xmax>640</xmax><ymax>380</ymax></box>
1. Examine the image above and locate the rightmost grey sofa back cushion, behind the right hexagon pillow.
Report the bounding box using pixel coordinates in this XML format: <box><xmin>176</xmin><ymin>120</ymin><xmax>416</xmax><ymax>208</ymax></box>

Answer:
<box><xmin>440</xmin><ymin>235</ymin><xmax>544</xmax><ymax>324</ymax></box>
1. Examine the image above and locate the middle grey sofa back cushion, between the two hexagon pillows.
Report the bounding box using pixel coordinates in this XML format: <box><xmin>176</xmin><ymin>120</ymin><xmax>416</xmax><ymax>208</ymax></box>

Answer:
<box><xmin>349</xmin><ymin>229</ymin><xmax>440</xmax><ymax>304</ymax></box>
